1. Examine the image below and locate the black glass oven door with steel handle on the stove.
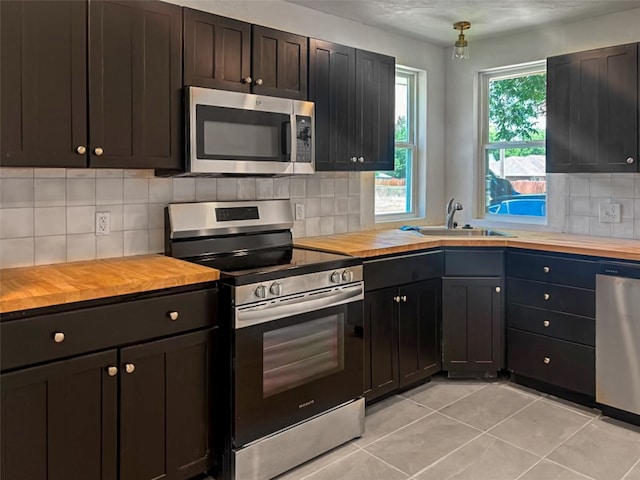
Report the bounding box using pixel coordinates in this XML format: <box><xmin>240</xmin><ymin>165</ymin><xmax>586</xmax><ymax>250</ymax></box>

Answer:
<box><xmin>233</xmin><ymin>283</ymin><xmax>364</xmax><ymax>447</ymax></box>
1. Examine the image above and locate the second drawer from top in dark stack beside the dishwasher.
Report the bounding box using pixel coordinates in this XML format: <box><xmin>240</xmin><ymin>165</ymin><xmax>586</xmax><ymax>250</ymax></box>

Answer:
<box><xmin>507</xmin><ymin>278</ymin><xmax>596</xmax><ymax>318</ymax></box>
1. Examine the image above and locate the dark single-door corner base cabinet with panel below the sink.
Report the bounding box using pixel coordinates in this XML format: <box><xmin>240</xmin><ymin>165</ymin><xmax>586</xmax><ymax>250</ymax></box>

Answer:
<box><xmin>442</xmin><ymin>249</ymin><xmax>504</xmax><ymax>377</ymax></box>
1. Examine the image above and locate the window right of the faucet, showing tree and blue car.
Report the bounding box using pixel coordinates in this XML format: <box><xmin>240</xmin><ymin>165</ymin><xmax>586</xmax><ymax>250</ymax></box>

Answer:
<box><xmin>480</xmin><ymin>62</ymin><xmax>547</xmax><ymax>220</ymax></box>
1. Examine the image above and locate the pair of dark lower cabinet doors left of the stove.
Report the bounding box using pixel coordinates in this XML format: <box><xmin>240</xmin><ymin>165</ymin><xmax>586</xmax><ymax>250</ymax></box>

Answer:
<box><xmin>0</xmin><ymin>329</ymin><xmax>215</xmax><ymax>480</ymax></box>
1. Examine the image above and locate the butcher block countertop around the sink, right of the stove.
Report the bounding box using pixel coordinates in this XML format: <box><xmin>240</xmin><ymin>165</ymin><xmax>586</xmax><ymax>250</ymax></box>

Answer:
<box><xmin>295</xmin><ymin>229</ymin><xmax>640</xmax><ymax>261</ymax></box>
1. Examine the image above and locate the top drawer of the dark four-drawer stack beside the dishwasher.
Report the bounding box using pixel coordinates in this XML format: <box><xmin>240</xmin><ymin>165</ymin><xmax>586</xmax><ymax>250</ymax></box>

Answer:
<box><xmin>507</xmin><ymin>252</ymin><xmax>597</xmax><ymax>290</ymax></box>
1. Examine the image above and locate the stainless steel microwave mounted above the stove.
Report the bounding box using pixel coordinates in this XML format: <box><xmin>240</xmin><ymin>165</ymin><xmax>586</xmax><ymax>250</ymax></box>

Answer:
<box><xmin>186</xmin><ymin>87</ymin><xmax>315</xmax><ymax>175</ymax></box>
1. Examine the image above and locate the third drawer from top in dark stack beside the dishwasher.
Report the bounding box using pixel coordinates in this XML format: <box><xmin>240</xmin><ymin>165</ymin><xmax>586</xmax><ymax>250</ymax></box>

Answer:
<box><xmin>507</xmin><ymin>303</ymin><xmax>596</xmax><ymax>347</ymax></box>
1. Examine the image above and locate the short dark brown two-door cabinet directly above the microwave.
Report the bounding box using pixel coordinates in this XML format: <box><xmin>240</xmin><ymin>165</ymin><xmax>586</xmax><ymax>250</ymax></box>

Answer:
<box><xmin>184</xmin><ymin>8</ymin><xmax>308</xmax><ymax>100</ymax></box>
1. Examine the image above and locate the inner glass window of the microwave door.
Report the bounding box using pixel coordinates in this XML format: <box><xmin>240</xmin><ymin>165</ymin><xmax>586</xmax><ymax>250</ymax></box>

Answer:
<box><xmin>204</xmin><ymin>120</ymin><xmax>280</xmax><ymax>158</ymax></box>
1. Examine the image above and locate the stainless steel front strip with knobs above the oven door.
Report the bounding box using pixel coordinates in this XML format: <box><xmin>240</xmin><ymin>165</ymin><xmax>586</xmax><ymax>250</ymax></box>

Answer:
<box><xmin>233</xmin><ymin>265</ymin><xmax>362</xmax><ymax>306</ymax></box>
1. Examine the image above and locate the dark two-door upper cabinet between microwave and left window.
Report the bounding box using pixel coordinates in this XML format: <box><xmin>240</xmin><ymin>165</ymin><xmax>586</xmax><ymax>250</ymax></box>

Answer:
<box><xmin>309</xmin><ymin>39</ymin><xmax>395</xmax><ymax>171</ymax></box>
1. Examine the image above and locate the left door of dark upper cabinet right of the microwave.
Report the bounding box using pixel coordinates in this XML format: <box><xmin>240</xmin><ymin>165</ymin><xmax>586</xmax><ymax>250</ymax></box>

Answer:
<box><xmin>309</xmin><ymin>39</ymin><xmax>356</xmax><ymax>171</ymax></box>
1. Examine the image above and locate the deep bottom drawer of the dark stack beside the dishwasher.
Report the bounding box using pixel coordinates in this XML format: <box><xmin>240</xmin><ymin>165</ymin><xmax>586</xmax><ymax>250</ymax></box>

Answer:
<box><xmin>507</xmin><ymin>328</ymin><xmax>595</xmax><ymax>396</ymax></box>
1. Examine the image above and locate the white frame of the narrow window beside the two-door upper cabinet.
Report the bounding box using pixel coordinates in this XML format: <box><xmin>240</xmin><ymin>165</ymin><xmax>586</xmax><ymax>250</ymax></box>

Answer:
<box><xmin>374</xmin><ymin>66</ymin><xmax>420</xmax><ymax>223</ymax></box>
